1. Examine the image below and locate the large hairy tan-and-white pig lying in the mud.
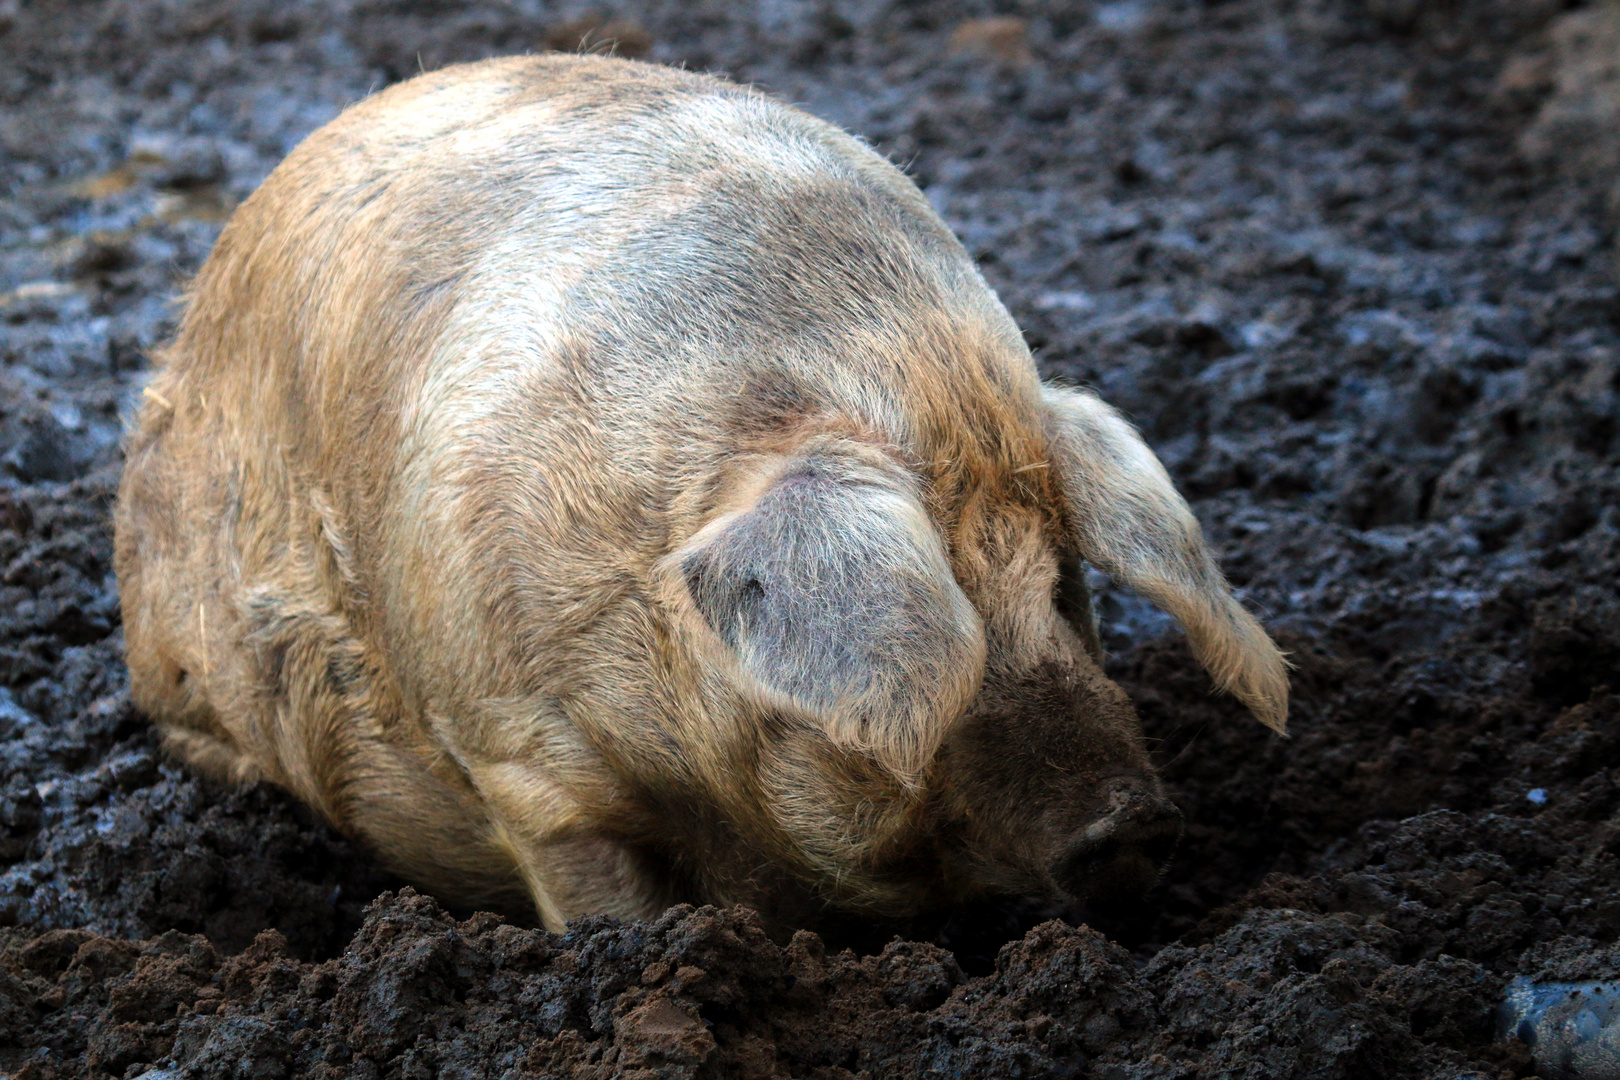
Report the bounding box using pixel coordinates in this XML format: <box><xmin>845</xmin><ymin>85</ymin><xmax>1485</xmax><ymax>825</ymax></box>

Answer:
<box><xmin>115</xmin><ymin>53</ymin><xmax>1288</xmax><ymax>929</ymax></box>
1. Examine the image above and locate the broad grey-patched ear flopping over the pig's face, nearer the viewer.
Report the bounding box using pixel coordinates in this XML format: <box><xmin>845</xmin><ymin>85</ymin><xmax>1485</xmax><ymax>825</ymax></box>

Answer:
<box><xmin>664</xmin><ymin>453</ymin><xmax>985</xmax><ymax>782</ymax></box>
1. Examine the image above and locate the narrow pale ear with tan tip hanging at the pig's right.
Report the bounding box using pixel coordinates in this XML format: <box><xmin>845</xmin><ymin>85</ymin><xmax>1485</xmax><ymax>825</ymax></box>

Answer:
<box><xmin>1043</xmin><ymin>387</ymin><xmax>1288</xmax><ymax>733</ymax></box>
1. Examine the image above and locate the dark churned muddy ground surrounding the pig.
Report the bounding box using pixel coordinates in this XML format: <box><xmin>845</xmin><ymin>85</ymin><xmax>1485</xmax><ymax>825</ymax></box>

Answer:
<box><xmin>0</xmin><ymin>0</ymin><xmax>1620</xmax><ymax>1080</ymax></box>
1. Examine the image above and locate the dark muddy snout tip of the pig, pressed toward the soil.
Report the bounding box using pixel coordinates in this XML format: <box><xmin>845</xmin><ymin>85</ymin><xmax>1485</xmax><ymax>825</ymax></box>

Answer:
<box><xmin>1051</xmin><ymin>779</ymin><xmax>1181</xmax><ymax>900</ymax></box>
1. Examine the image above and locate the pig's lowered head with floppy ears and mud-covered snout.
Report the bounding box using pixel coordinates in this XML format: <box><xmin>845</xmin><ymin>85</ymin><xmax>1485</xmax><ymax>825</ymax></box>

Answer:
<box><xmin>651</xmin><ymin>387</ymin><xmax>1288</xmax><ymax>915</ymax></box>
